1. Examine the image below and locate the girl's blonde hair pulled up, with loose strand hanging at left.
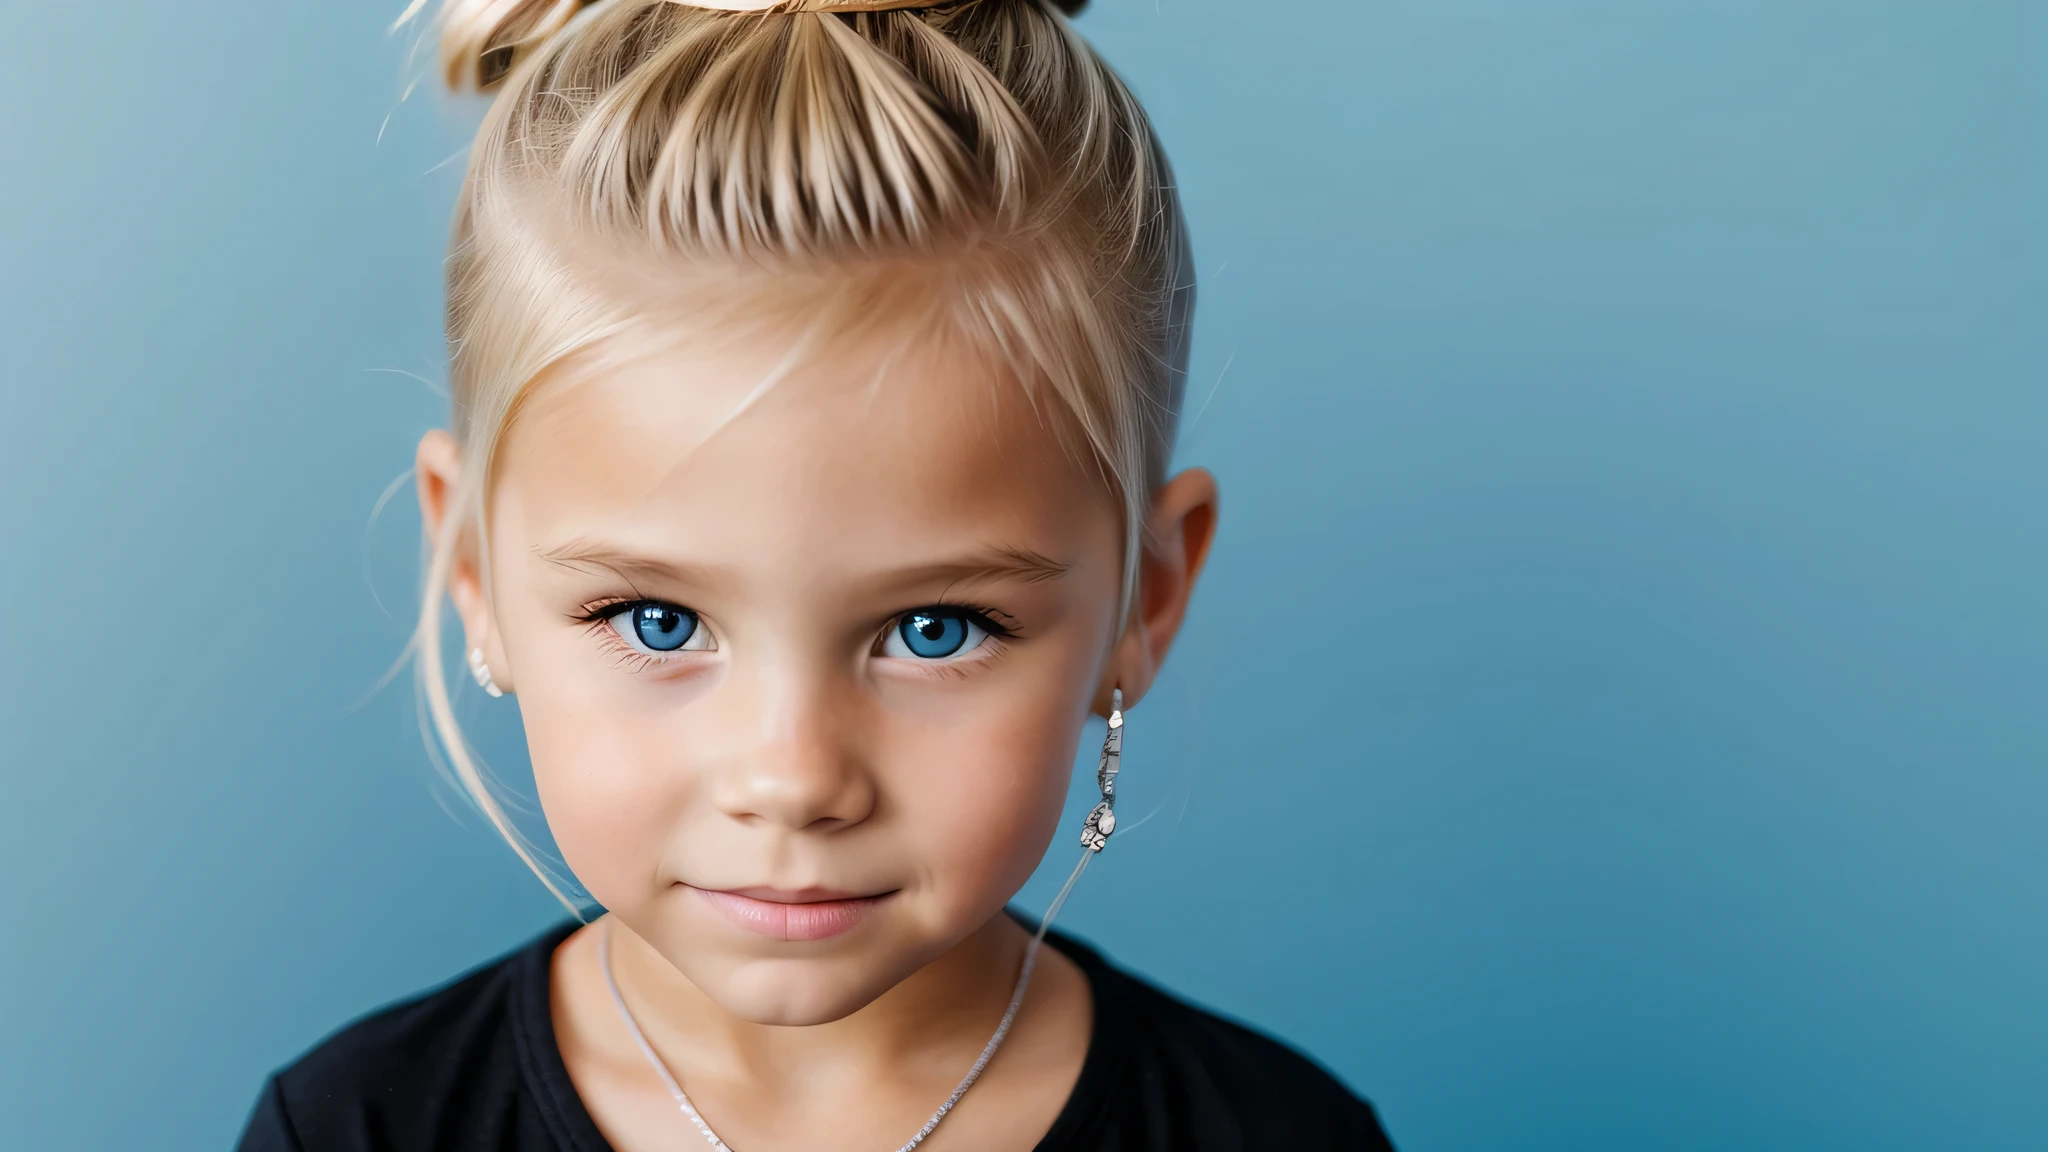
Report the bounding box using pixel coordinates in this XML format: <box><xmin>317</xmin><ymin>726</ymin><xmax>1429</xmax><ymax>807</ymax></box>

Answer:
<box><xmin>399</xmin><ymin>0</ymin><xmax>1194</xmax><ymax>910</ymax></box>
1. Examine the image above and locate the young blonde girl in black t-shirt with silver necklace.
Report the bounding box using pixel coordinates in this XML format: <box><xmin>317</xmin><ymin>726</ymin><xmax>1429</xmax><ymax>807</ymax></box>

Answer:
<box><xmin>242</xmin><ymin>0</ymin><xmax>1386</xmax><ymax>1152</ymax></box>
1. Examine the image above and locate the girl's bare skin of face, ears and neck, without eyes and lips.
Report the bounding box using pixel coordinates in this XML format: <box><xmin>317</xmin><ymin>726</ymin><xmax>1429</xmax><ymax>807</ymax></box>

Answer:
<box><xmin>418</xmin><ymin>313</ymin><xmax>1217</xmax><ymax>1152</ymax></box>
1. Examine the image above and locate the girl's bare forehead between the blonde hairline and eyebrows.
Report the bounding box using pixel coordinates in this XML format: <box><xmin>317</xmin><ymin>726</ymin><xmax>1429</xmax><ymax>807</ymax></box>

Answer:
<box><xmin>494</xmin><ymin>317</ymin><xmax>1116</xmax><ymax>574</ymax></box>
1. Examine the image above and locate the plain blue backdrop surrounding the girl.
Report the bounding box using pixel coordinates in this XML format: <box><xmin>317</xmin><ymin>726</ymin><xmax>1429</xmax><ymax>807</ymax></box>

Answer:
<box><xmin>0</xmin><ymin>0</ymin><xmax>2048</xmax><ymax>1152</ymax></box>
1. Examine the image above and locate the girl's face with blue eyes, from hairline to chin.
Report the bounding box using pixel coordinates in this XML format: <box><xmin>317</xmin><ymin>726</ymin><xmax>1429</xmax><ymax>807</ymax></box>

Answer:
<box><xmin>434</xmin><ymin>319</ymin><xmax>1206</xmax><ymax>1025</ymax></box>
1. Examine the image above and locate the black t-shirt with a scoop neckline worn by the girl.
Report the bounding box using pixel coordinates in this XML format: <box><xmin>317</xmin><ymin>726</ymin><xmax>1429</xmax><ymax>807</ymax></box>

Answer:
<box><xmin>240</xmin><ymin>924</ymin><xmax>1393</xmax><ymax>1152</ymax></box>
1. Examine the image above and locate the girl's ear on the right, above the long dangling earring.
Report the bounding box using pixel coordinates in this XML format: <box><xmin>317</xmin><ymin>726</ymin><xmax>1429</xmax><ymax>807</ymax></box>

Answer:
<box><xmin>1096</xmin><ymin>467</ymin><xmax>1217</xmax><ymax>715</ymax></box>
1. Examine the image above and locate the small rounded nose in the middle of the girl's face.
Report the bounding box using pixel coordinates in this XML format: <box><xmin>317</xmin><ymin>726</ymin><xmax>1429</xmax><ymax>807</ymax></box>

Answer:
<box><xmin>711</xmin><ymin>670</ymin><xmax>874</xmax><ymax>832</ymax></box>
